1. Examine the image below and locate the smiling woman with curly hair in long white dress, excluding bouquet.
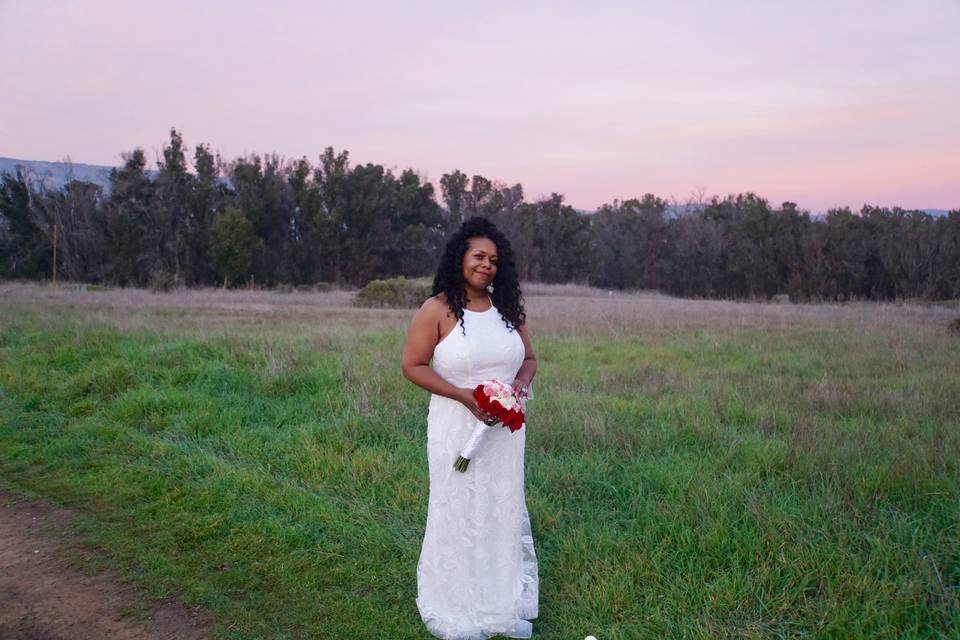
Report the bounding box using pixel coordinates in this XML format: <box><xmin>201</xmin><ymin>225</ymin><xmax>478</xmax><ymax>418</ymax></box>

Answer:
<box><xmin>403</xmin><ymin>217</ymin><xmax>538</xmax><ymax>640</ymax></box>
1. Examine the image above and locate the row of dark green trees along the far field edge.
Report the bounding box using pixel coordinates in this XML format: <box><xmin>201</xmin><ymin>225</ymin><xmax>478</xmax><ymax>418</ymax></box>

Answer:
<box><xmin>0</xmin><ymin>130</ymin><xmax>960</xmax><ymax>300</ymax></box>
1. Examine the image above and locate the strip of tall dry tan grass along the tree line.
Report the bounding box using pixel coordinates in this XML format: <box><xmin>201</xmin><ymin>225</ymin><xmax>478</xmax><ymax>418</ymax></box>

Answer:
<box><xmin>0</xmin><ymin>283</ymin><xmax>956</xmax><ymax>336</ymax></box>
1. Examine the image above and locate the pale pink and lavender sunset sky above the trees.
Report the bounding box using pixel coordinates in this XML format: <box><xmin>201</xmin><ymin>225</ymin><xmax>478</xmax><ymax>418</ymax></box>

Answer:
<box><xmin>0</xmin><ymin>0</ymin><xmax>960</xmax><ymax>212</ymax></box>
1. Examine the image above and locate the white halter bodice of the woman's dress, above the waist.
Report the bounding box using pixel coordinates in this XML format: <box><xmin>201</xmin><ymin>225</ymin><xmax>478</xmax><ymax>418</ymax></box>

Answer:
<box><xmin>433</xmin><ymin>304</ymin><xmax>524</xmax><ymax>387</ymax></box>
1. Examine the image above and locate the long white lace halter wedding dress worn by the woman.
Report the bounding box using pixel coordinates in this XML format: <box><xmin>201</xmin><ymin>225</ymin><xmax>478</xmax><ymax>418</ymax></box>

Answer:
<box><xmin>417</xmin><ymin>306</ymin><xmax>538</xmax><ymax>640</ymax></box>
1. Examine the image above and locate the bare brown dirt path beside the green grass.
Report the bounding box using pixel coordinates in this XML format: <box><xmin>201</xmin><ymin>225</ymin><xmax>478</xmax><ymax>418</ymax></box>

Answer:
<box><xmin>0</xmin><ymin>491</ymin><xmax>212</xmax><ymax>640</ymax></box>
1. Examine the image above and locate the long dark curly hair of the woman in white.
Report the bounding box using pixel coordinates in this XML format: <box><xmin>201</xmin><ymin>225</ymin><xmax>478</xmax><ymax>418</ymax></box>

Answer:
<box><xmin>431</xmin><ymin>216</ymin><xmax>527</xmax><ymax>335</ymax></box>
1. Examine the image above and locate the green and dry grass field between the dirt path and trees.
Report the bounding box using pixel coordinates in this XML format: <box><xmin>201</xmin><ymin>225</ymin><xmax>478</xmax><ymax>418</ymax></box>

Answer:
<box><xmin>0</xmin><ymin>284</ymin><xmax>960</xmax><ymax>640</ymax></box>
